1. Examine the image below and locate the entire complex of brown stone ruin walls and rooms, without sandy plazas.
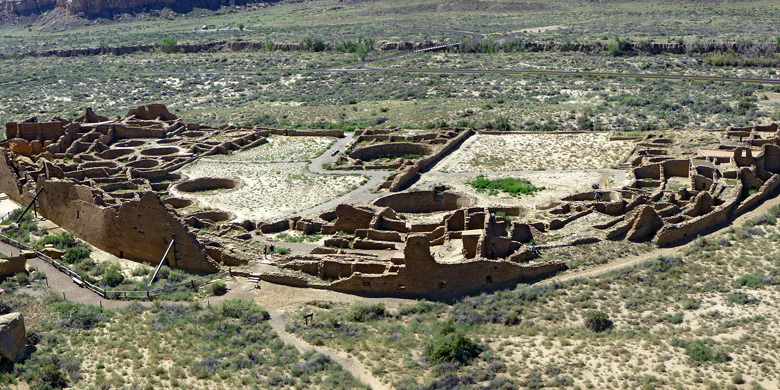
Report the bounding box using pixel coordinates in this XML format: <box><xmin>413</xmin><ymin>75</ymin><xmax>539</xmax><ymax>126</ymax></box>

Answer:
<box><xmin>0</xmin><ymin>105</ymin><xmax>780</xmax><ymax>297</ymax></box>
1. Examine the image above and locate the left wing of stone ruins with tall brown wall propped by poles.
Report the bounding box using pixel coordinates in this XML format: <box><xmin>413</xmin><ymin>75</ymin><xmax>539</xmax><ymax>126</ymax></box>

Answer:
<box><xmin>0</xmin><ymin>104</ymin><xmax>343</xmax><ymax>273</ymax></box>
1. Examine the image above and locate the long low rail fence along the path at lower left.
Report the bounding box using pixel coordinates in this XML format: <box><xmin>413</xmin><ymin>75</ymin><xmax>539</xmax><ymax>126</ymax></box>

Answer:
<box><xmin>0</xmin><ymin>234</ymin><xmax>227</xmax><ymax>300</ymax></box>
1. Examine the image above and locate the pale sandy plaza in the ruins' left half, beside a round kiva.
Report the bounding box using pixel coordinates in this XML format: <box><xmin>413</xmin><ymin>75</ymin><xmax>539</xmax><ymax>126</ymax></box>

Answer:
<box><xmin>171</xmin><ymin>160</ymin><xmax>365</xmax><ymax>221</ymax></box>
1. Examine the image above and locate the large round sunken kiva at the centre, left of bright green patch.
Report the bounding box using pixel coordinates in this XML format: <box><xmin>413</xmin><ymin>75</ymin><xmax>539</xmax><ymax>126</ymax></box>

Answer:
<box><xmin>374</xmin><ymin>191</ymin><xmax>477</xmax><ymax>213</ymax></box>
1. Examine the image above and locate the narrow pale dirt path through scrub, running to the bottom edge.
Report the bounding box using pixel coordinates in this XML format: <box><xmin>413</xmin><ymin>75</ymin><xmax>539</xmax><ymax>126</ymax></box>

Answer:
<box><xmin>267</xmin><ymin>309</ymin><xmax>390</xmax><ymax>390</ymax></box>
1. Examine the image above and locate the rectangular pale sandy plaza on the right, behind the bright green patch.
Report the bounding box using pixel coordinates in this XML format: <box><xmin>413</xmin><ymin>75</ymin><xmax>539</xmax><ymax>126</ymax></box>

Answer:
<box><xmin>434</xmin><ymin>133</ymin><xmax>634</xmax><ymax>172</ymax></box>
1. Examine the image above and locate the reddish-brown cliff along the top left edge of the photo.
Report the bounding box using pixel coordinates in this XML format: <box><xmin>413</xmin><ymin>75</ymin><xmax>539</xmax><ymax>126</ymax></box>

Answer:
<box><xmin>0</xmin><ymin>0</ymin><xmax>260</xmax><ymax>17</ymax></box>
